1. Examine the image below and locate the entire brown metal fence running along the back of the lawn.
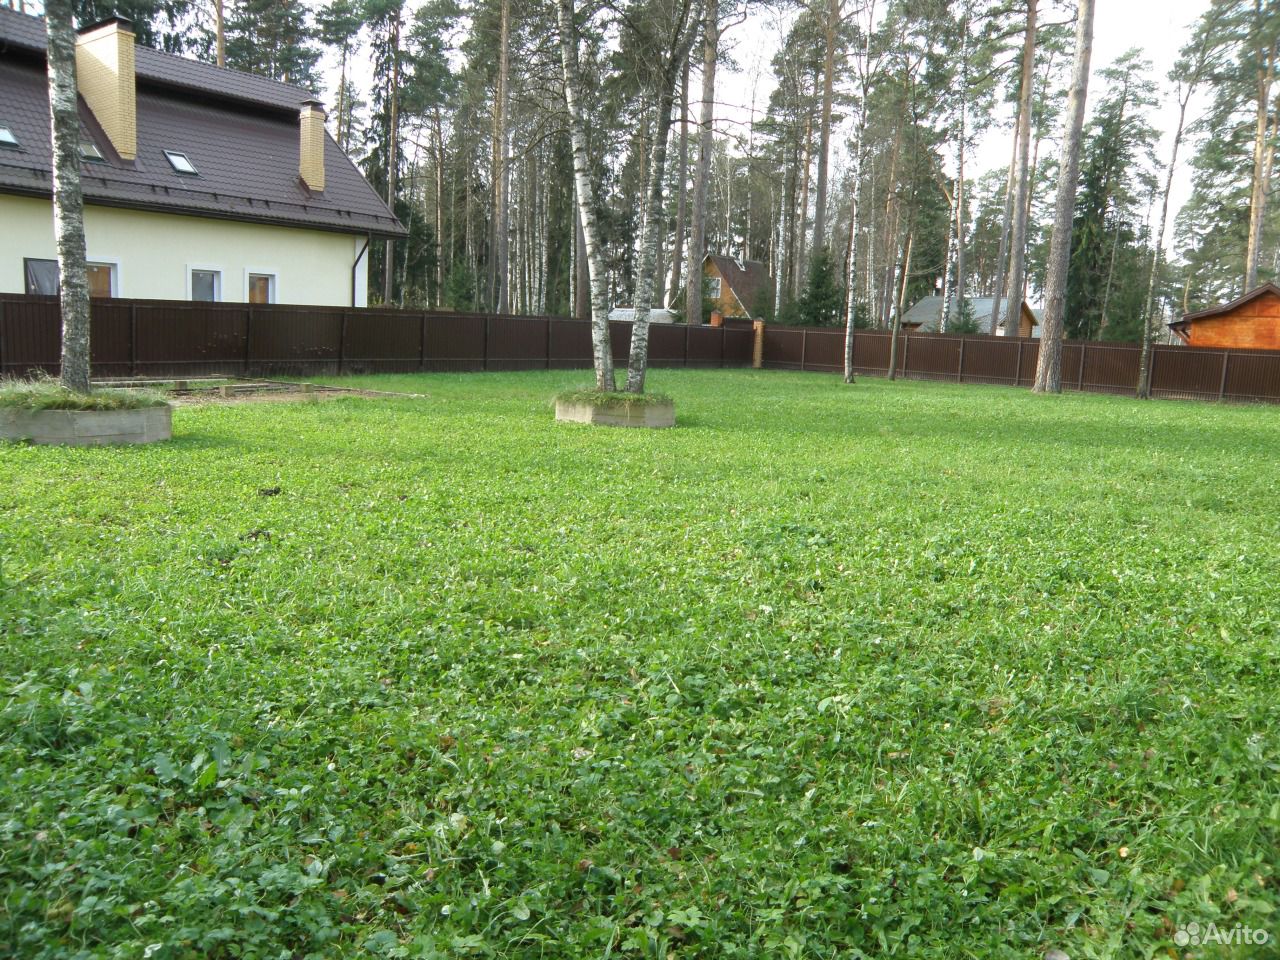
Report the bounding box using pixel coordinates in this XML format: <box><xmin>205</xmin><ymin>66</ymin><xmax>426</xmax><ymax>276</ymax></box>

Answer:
<box><xmin>0</xmin><ymin>294</ymin><xmax>1280</xmax><ymax>402</ymax></box>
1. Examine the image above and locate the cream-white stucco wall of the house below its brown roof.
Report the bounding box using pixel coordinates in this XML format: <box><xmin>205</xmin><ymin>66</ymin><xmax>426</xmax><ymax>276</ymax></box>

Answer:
<box><xmin>0</xmin><ymin>195</ymin><xmax>367</xmax><ymax>307</ymax></box>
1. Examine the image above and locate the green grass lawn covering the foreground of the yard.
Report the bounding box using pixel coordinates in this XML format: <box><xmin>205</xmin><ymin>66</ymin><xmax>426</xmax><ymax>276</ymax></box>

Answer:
<box><xmin>0</xmin><ymin>371</ymin><xmax>1280</xmax><ymax>960</ymax></box>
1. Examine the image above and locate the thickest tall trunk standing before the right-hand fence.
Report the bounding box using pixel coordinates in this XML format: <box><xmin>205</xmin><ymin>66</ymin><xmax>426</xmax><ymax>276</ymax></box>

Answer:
<box><xmin>1032</xmin><ymin>0</ymin><xmax>1090</xmax><ymax>393</ymax></box>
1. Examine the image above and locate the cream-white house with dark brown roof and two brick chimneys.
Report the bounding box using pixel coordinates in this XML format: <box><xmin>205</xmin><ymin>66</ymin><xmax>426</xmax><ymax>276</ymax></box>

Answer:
<box><xmin>0</xmin><ymin>6</ymin><xmax>404</xmax><ymax>306</ymax></box>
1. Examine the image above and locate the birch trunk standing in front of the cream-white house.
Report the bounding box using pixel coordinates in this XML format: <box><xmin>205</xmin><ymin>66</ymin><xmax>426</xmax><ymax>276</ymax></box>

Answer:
<box><xmin>45</xmin><ymin>0</ymin><xmax>90</xmax><ymax>393</ymax></box>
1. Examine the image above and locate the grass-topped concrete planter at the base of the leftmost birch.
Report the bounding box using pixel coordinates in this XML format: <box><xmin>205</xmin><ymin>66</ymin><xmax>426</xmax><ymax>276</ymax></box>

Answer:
<box><xmin>0</xmin><ymin>380</ymin><xmax>173</xmax><ymax>447</ymax></box>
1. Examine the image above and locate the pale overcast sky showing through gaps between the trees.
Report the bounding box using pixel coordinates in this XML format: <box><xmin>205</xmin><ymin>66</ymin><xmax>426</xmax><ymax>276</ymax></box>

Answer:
<box><xmin>314</xmin><ymin>0</ymin><xmax>1210</xmax><ymax>252</ymax></box>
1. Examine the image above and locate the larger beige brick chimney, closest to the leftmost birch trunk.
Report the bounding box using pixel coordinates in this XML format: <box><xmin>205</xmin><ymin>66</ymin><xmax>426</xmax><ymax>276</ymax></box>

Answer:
<box><xmin>76</xmin><ymin>17</ymin><xmax>138</xmax><ymax>160</ymax></box>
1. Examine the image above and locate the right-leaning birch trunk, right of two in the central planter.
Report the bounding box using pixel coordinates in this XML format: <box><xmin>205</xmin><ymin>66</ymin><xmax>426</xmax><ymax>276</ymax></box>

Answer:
<box><xmin>626</xmin><ymin>0</ymin><xmax>700</xmax><ymax>393</ymax></box>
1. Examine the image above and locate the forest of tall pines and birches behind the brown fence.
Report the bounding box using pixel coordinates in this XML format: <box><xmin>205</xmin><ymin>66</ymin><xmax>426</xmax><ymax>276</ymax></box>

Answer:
<box><xmin>27</xmin><ymin>0</ymin><xmax>1280</xmax><ymax>340</ymax></box>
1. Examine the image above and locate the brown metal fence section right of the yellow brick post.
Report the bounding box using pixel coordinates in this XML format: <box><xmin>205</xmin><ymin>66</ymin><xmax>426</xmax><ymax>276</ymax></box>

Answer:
<box><xmin>764</xmin><ymin>326</ymin><xmax>1280</xmax><ymax>403</ymax></box>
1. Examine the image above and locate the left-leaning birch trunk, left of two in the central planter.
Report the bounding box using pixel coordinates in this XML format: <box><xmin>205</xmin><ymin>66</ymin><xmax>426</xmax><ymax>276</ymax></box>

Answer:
<box><xmin>558</xmin><ymin>0</ymin><xmax>614</xmax><ymax>393</ymax></box>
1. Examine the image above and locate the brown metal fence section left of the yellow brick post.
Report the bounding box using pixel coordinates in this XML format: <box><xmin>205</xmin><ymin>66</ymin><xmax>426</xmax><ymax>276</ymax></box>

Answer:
<box><xmin>0</xmin><ymin>294</ymin><xmax>753</xmax><ymax>378</ymax></box>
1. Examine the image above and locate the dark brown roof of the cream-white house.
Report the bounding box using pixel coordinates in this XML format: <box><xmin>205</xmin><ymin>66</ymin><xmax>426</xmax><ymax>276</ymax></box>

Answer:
<box><xmin>0</xmin><ymin>8</ymin><xmax>404</xmax><ymax>236</ymax></box>
